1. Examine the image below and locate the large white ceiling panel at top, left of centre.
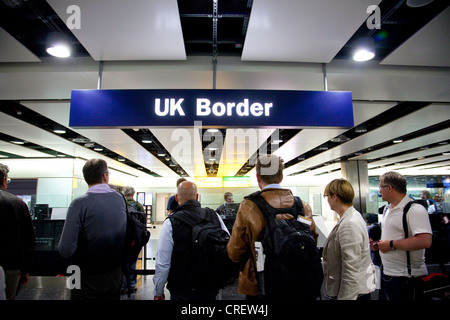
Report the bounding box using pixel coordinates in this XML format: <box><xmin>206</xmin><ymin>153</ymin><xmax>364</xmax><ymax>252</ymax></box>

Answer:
<box><xmin>47</xmin><ymin>0</ymin><xmax>186</xmax><ymax>61</ymax></box>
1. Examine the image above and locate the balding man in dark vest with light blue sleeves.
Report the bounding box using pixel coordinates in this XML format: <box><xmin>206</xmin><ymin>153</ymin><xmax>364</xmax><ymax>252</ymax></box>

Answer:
<box><xmin>153</xmin><ymin>181</ymin><xmax>228</xmax><ymax>300</ymax></box>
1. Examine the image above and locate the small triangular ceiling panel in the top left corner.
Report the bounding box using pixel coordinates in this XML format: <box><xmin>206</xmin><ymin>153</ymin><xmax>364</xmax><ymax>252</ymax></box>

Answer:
<box><xmin>0</xmin><ymin>27</ymin><xmax>41</xmax><ymax>62</ymax></box>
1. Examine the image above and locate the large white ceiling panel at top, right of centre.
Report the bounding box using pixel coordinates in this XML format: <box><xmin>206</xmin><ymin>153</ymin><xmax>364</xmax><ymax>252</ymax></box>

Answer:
<box><xmin>242</xmin><ymin>0</ymin><xmax>381</xmax><ymax>63</ymax></box>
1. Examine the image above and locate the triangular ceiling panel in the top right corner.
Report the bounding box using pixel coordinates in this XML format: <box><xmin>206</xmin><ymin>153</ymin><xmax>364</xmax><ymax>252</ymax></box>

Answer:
<box><xmin>381</xmin><ymin>7</ymin><xmax>450</xmax><ymax>67</ymax></box>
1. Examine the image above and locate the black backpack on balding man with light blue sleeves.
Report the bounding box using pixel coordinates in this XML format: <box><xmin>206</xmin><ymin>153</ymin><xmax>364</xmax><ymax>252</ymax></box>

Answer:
<box><xmin>169</xmin><ymin>208</ymin><xmax>239</xmax><ymax>294</ymax></box>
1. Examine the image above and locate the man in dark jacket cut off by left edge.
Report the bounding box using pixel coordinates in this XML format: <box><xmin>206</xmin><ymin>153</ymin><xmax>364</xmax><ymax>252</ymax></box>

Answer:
<box><xmin>0</xmin><ymin>163</ymin><xmax>35</xmax><ymax>300</ymax></box>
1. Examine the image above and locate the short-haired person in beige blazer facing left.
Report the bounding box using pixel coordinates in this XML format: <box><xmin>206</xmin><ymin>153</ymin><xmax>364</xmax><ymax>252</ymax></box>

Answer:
<box><xmin>323</xmin><ymin>179</ymin><xmax>376</xmax><ymax>300</ymax></box>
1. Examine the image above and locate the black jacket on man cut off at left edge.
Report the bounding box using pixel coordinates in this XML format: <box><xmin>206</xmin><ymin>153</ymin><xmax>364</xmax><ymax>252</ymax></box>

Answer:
<box><xmin>0</xmin><ymin>190</ymin><xmax>36</xmax><ymax>273</ymax></box>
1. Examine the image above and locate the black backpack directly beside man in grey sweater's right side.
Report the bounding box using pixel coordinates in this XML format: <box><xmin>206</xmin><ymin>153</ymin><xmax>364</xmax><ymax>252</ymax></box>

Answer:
<box><xmin>122</xmin><ymin>197</ymin><xmax>150</xmax><ymax>297</ymax></box>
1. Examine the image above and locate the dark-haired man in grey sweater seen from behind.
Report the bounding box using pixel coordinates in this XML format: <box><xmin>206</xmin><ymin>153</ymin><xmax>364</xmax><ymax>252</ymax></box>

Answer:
<box><xmin>58</xmin><ymin>159</ymin><xmax>126</xmax><ymax>300</ymax></box>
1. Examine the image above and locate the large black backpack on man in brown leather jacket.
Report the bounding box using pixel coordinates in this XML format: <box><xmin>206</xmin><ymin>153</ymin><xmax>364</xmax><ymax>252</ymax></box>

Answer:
<box><xmin>245</xmin><ymin>191</ymin><xmax>323</xmax><ymax>300</ymax></box>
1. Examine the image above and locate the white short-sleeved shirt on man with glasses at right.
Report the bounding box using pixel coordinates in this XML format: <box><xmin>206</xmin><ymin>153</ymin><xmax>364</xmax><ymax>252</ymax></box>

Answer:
<box><xmin>380</xmin><ymin>195</ymin><xmax>432</xmax><ymax>277</ymax></box>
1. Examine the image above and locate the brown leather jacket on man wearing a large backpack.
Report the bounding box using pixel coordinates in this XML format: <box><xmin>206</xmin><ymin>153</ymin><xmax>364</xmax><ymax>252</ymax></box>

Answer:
<box><xmin>228</xmin><ymin>188</ymin><xmax>318</xmax><ymax>296</ymax></box>
